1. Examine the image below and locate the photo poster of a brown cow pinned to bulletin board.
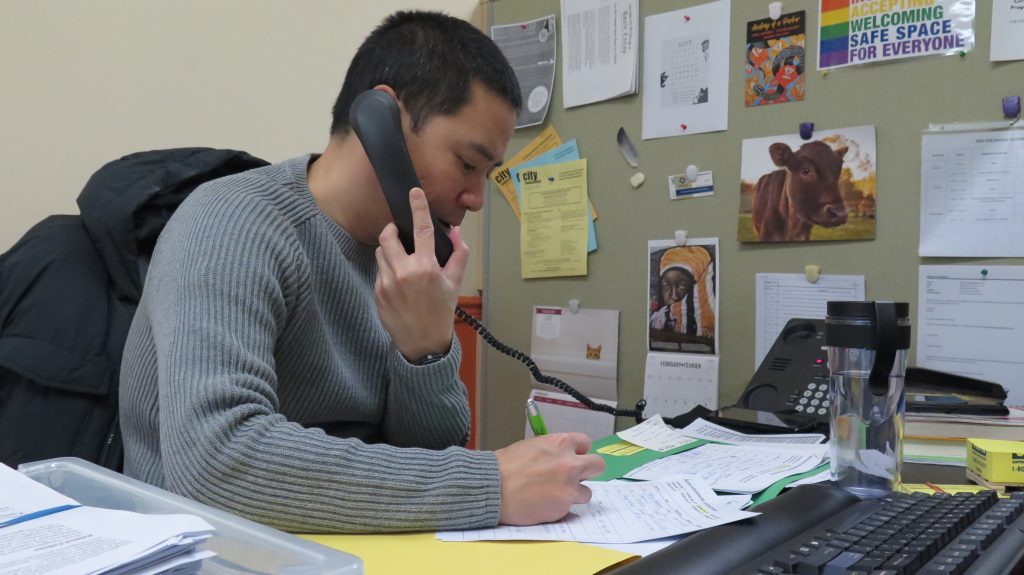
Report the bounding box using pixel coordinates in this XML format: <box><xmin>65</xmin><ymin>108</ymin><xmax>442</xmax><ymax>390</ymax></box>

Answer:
<box><xmin>736</xmin><ymin>126</ymin><xmax>877</xmax><ymax>241</ymax></box>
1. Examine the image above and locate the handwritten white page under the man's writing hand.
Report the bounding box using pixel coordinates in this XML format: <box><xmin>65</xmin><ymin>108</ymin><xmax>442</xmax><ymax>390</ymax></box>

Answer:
<box><xmin>437</xmin><ymin>477</ymin><xmax>759</xmax><ymax>543</ymax></box>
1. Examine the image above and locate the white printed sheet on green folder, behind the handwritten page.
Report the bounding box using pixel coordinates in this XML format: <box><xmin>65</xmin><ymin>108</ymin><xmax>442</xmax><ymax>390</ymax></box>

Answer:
<box><xmin>626</xmin><ymin>443</ymin><xmax>828</xmax><ymax>493</ymax></box>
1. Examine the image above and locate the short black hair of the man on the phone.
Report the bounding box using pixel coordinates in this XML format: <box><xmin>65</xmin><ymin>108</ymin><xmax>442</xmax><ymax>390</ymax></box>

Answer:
<box><xmin>331</xmin><ymin>10</ymin><xmax>522</xmax><ymax>135</ymax></box>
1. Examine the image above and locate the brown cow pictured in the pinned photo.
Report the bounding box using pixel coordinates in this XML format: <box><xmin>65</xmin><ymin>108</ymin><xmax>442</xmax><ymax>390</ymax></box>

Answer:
<box><xmin>754</xmin><ymin>141</ymin><xmax>847</xmax><ymax>241</ymax></box>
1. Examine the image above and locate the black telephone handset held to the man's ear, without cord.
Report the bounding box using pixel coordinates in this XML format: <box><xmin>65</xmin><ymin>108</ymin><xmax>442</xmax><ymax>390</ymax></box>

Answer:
<box><xmin>348</xmin><ymin>90</ymin><xmax>454</xmax><ymax>267</ymax></box>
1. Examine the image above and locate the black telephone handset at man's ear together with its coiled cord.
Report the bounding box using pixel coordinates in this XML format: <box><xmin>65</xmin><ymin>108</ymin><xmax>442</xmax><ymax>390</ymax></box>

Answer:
<box><xmin>348</xmin><ymin>90</ymin><xmax>646</xmax><ymax>423</ymax></box>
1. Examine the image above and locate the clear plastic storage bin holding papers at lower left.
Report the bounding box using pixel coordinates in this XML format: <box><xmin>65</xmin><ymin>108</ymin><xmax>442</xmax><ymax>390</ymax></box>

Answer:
<box><xmin>17</xmin><ymin>457</ymin><xmax>362</xmax><ymax>575</ymax></box>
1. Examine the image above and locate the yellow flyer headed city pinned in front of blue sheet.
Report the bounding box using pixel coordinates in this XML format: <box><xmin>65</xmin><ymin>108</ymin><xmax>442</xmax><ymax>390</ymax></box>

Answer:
<box><xmin>519</xmin><ymin>160</ymin><xmax>590</xmax><ymax>279</ymax></box>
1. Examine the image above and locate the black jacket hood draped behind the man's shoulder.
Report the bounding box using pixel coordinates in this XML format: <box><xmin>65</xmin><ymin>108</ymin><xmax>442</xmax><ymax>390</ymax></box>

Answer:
<box><xmin>78</xmin><ymin>147</ymin><xmax>268</xmax><ymax>302</ymax></box>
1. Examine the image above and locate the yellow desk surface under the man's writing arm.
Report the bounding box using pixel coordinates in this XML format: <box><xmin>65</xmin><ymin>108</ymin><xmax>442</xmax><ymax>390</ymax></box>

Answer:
<box><xmin>299</xmin><ymin>533</ymin><xmax>636</xmax><ymax>575</ymax></box>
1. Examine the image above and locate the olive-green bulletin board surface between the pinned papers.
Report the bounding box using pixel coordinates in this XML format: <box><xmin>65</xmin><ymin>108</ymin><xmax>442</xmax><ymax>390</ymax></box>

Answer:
<box><xmin>479</xmin><ymin>0</ymin><xmax>1024</xmax><ymax>448</ymax></box>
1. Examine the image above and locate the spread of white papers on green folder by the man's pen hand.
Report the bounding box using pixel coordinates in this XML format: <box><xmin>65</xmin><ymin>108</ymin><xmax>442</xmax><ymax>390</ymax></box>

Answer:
<box><xmin>437</xmin><ymin>415</ymin><xmax>827</xmax><ymax>555</ymax></box>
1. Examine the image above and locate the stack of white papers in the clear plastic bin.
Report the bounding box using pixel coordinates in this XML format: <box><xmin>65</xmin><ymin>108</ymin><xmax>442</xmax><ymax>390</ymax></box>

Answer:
<box><xmin>0</xmin><ymin>465</ymin><xmax>214</xmax><ymax>575</ymax></box>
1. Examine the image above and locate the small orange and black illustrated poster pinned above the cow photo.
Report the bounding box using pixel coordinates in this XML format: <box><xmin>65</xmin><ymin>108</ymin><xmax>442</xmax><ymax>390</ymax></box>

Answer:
<box><xmin>743</xmin><ymin>10</ymin><xmax>807</xmax><ymax>107</ymax></box>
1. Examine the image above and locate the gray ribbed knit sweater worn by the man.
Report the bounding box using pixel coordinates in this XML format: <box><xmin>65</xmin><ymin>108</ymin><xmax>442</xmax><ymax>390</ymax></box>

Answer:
<box><xmin>121</xmin><ymin>156</ymin><xmax>500</xmax><ymax>533</ymax></box>
